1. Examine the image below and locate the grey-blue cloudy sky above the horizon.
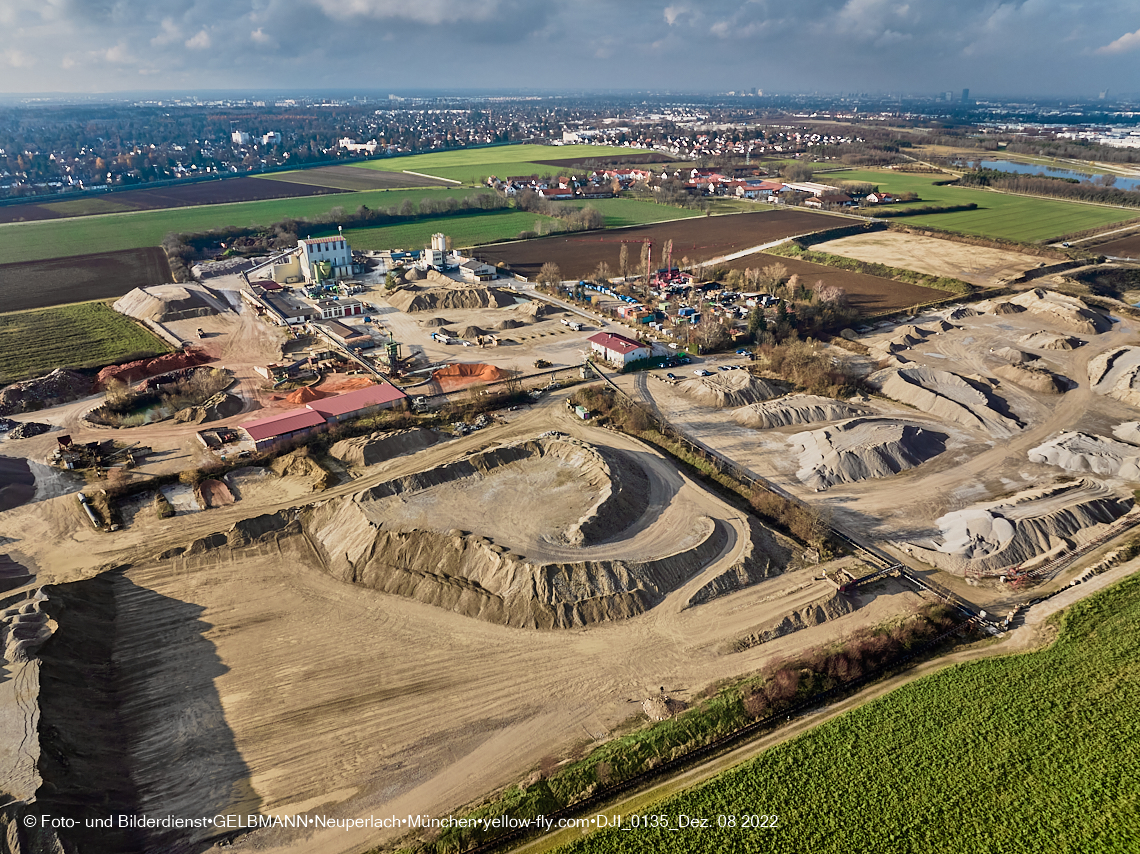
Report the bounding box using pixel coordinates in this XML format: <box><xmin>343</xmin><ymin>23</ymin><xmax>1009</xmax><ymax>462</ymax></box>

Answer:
<box><xmin>0</xmin><ymin>0</ymin><xmax>1140</xmax><ymax>97</ymax></box>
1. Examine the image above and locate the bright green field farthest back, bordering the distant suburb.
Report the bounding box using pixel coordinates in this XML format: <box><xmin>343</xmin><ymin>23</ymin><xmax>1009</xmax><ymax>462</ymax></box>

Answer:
<box><xmin>358</xmin><ymin>145</ymin><xmax>661</xmax><ymax>184</ymax></box>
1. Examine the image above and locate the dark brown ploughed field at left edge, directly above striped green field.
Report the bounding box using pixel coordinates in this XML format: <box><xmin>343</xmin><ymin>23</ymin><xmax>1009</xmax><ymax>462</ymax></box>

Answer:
<box><xmin>0</xmin><ymin>246</ymin><xmax>174</xmax><ymax>311</ymax></box>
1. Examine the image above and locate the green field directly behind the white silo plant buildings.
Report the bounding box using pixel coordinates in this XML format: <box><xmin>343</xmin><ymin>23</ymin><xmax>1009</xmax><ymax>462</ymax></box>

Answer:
<box><xmin>344</xmin><ymin>211</ymin><xmax>556</xmax><ymax>250</ymax></box>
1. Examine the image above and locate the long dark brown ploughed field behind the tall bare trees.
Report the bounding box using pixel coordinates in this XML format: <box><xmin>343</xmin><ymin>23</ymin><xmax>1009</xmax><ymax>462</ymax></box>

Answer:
<box><xmin>475</xmin><ymin>210</ymin><xmax>844</xmax><ymax>278</ymax></box>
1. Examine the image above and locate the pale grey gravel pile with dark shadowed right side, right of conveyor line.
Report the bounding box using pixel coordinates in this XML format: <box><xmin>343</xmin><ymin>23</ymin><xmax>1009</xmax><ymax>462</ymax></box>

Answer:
<box><xmin>790</xmin><ymin>418</ymin><xmax>946</xmax><ymax>491</ymax></box>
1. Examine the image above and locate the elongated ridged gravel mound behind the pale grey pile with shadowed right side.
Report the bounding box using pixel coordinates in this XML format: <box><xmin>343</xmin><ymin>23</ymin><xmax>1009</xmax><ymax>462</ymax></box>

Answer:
<box><xmin>868</xmin><ymin>366</ymin><xmax>1021</xmax><ymax>437</ymax></box>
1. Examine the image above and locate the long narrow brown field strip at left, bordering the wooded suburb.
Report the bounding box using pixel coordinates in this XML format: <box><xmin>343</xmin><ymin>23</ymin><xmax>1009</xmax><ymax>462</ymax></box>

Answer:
<box><xmin>0</xmin><ymin>178</ymin><xmax>344</xmax><ymax>222</ymax></box>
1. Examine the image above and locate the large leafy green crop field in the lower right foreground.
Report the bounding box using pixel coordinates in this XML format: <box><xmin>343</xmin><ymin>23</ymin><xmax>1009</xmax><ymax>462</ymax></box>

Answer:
<box><xmin>561</xmin><ymin>575</ymin><xmax>1140</xmax><ymax>854</ymax></box>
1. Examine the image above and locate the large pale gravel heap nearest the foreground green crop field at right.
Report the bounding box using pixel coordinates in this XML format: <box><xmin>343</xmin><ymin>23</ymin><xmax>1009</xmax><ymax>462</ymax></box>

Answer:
<box><xmin>905</xmin><ymin>480</ymin><xmax>1132</xmax><ymax>574</ymax></box>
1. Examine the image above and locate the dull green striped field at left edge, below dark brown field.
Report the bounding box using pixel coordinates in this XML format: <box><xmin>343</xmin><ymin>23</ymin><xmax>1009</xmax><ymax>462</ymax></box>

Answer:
<box><xmin>0</xmin><ymin>302</ymin><xmax>170</xmax><ymax>385</ymax></box>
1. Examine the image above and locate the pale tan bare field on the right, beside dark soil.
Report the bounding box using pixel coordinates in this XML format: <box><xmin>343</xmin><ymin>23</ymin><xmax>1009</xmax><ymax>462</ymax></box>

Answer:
<box><xmin>812</xmin><ymin>231</ymin><xmax>1041</xmax><ymax>285</ymax></box>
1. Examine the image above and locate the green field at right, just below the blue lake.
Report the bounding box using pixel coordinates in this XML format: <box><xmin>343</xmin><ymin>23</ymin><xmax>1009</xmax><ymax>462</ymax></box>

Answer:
<box><xmin>834</xmin><ymin>170</ymin><xmax>1138</xmax><ymax>243</ymax></box>
